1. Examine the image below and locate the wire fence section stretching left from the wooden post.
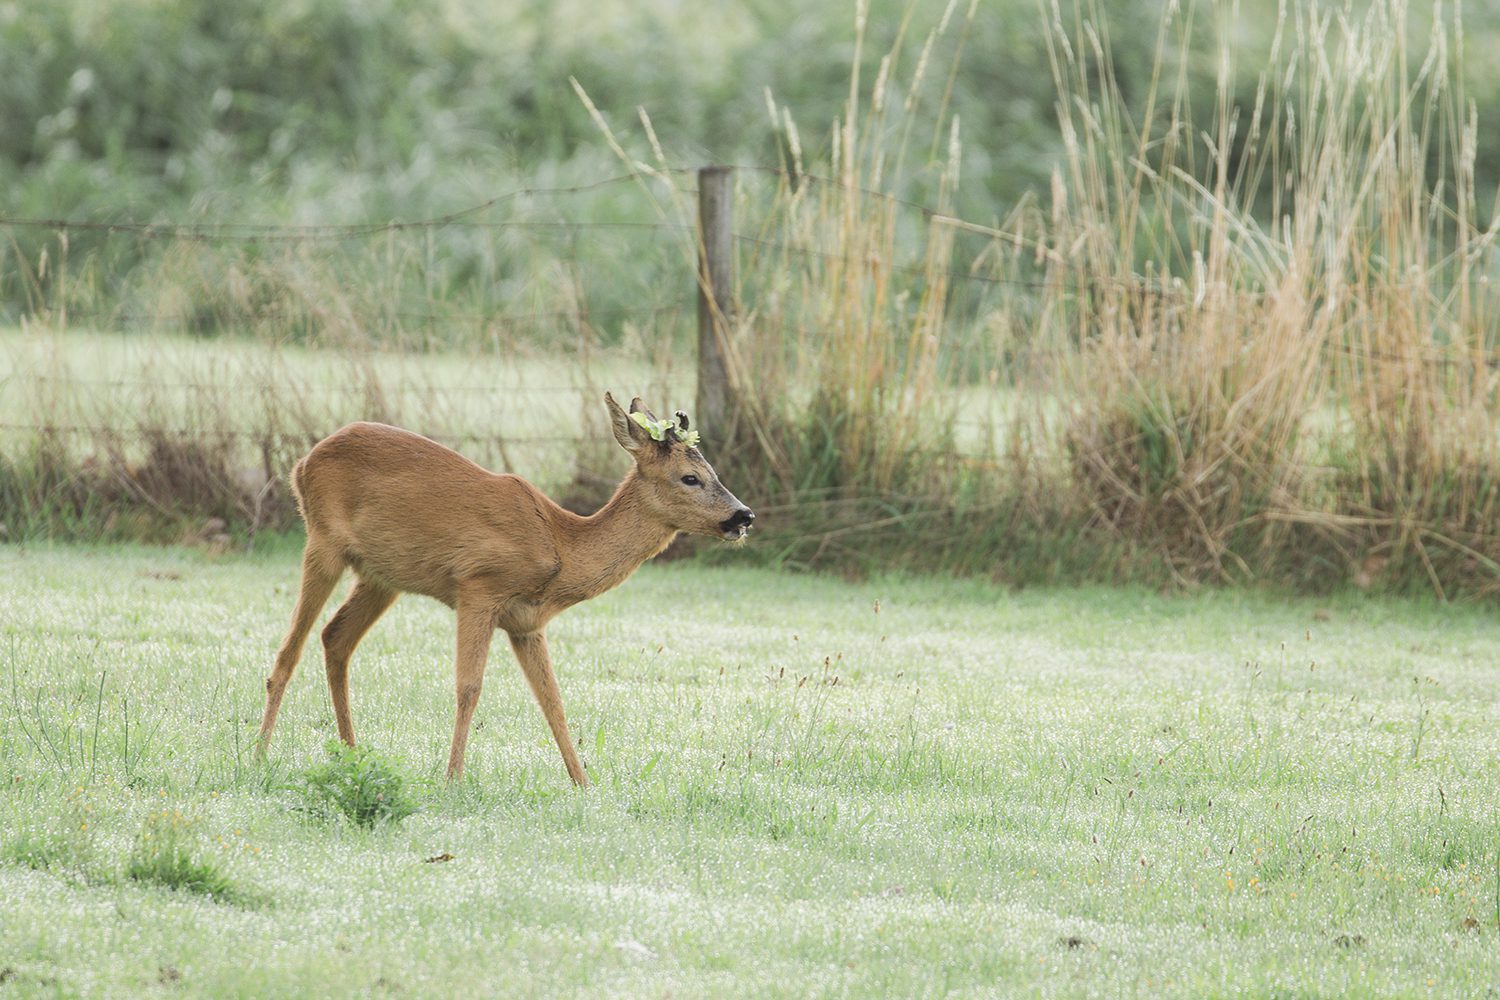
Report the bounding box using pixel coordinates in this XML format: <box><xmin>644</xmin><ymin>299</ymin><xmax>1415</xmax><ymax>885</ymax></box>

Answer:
<box><xmin>0</xmin><ymin>169</ymin><xmax>878</xmax><ymax>470</ymax></box>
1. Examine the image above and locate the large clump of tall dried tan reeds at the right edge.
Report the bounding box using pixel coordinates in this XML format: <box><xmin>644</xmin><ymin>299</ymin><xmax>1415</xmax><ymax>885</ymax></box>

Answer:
<box><xmin>1013</xmin><ymin>0</ymin><xmax>1500</xmax><ymax>592</ymax></box>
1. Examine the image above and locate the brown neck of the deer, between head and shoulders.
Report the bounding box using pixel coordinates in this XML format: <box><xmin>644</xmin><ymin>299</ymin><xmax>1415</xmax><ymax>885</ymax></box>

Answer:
<box><xmin>558</xmin><ymin>469</ymin><xmax>677</xmax><ymax>603</ymax></box>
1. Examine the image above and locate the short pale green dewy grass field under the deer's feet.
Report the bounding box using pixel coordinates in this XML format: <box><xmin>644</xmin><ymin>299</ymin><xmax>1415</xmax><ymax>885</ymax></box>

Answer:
<box><xmin>0</xmin><ymin>544</ymin><xmax>1500</xmax><ymax>997</ymax></box>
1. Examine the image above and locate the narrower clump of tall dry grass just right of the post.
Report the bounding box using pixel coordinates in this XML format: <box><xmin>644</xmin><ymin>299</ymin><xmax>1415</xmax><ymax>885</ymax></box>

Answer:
<box><xmin>744</xmin><ymin>0</ymin><xmax>977</xmax><ymax>495</ymax></box>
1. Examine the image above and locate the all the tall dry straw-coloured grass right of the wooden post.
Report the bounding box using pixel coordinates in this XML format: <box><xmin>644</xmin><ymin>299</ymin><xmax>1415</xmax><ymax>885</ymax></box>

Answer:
<box><xmin>699</xmin><ymin>0</ymin><xmax>1500</xmax><ymax>594</ymax></box>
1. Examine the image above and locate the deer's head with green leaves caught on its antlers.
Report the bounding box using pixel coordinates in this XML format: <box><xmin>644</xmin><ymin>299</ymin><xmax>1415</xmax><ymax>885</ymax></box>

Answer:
<box><xmin>605</xmin><ymin>393</ymin><xmax>755</xmax><ymax>541</ymax></box>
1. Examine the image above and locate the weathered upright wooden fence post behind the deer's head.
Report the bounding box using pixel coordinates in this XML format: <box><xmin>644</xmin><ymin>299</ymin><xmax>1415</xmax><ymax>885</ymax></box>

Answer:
<box><xmin>693</xmin><ymin>166</ymin><xmax>735</xmax><ymax>447</ymax></box>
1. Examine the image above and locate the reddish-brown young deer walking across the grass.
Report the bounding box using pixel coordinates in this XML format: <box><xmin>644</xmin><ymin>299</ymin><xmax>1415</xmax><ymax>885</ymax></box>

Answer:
<box><xmin>258</xmin><ymin>393</ymin><xmax>755</xmax><ymax>786</ymax></box>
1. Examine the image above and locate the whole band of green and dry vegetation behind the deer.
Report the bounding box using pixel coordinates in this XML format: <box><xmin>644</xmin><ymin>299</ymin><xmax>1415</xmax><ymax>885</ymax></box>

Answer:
<box><xmin>0</xmin><ymin>0</ymin><xmax>1500</xmax><ymax>595</ymax></box>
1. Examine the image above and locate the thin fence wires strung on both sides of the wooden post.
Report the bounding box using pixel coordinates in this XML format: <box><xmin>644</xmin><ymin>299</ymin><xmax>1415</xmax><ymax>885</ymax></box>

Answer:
<box><xmin>0</xmin><ymin>165</ymin><xmax>1500</xmax><ymax>460</ymax></box>
